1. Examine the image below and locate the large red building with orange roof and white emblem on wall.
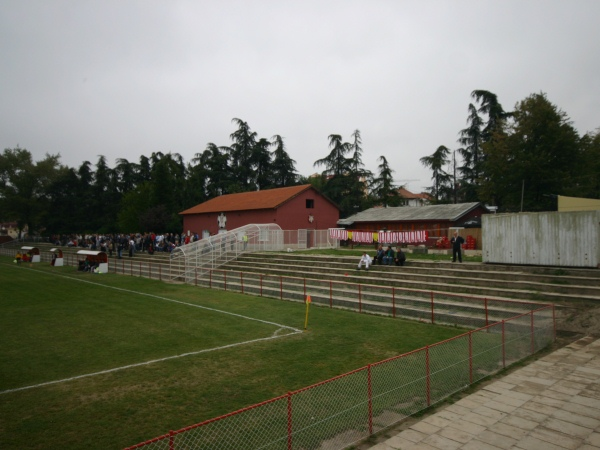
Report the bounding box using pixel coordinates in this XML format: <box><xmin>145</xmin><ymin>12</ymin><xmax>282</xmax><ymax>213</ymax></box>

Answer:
<box><xmin>179</xmin><ymin>184</ymin><xmax>340</xmax><ymax>237</ymax></box>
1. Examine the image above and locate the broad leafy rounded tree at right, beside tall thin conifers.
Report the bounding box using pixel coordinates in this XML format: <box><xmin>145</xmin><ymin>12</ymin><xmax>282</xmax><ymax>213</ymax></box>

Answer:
<box><xmin>482</xmin><ymin>93</ymin><xmax>581</xmax><ymax>211</ymax></box>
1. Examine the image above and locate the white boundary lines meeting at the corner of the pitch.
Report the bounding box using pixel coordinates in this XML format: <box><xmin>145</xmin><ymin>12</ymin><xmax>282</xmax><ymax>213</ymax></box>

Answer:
<box><xmin>0</xmin><ymin>264</ymin><xmax>302</xmax><ymax>395</ymax></box>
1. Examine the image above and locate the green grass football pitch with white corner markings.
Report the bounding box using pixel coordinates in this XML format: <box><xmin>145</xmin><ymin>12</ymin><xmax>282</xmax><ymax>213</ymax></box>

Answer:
<box><xmin>0</xmin><ymin>257</ymin><xmax>462</xmax><ymax>449</ymax></box>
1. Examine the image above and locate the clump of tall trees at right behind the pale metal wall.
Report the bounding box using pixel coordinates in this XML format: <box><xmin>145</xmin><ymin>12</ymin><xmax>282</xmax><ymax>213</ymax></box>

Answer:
<box><xmin>421</xmin><ymin>90</ymin><xmax>600</xmax><ymax>212</ymax></box>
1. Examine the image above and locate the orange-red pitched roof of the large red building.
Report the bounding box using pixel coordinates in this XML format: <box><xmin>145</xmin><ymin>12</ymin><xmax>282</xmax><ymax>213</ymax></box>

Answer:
<box><xmin>179</xmin><ymin>184</ymin><xmax>314</xmax><ymax>214</ymax></box>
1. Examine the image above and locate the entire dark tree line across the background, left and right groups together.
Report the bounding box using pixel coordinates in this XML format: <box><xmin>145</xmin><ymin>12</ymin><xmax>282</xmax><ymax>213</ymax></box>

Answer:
<box><xmin>0</xmin><ymin>90</ymin><xmax>600</xmax><ymax>235</ymax></box>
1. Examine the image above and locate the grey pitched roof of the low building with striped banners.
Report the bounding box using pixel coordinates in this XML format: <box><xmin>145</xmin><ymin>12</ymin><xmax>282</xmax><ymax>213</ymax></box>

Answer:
<box><xmin>337</xmin><ymin>202</ymin><xmax>483</xmax><ymax>225</ymax></box>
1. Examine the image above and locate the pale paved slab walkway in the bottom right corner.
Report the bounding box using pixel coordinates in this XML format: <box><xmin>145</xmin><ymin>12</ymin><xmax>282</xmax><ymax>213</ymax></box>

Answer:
<box><xmin>371</xmin><ymin>337</ymin><xmax>600</xmax><ymax>450</ymax></box>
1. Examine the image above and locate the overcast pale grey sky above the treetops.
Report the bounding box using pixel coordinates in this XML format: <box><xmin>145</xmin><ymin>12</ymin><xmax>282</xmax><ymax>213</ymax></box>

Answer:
<box><xmin>0</xmin><ymin>0</ymin><xmax>600</xmax><ymax>192</ymax></box>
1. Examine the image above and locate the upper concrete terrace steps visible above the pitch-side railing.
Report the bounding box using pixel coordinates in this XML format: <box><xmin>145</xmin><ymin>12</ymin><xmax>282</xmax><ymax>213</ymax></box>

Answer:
<box><xmin>223</xmin><ymin>253</ymin><xmax>600</xmax><ymax>302</ymax></box>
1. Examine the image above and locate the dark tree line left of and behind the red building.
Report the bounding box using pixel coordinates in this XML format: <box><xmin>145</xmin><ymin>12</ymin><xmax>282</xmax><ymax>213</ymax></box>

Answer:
<box><xmin>0</xmin><ymin>118</ymin><xmax>399</xmax><ymax>235</ymax></box>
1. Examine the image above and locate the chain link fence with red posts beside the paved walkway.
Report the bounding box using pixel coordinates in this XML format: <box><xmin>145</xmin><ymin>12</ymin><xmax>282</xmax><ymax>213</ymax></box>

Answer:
<box><xmin>127</xmin><ymin>305</ymin><xmax>554</xmax><ymax>450</ymax></box>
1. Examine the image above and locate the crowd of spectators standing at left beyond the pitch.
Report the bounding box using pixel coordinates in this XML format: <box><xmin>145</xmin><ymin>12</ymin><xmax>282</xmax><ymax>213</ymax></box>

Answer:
<box><xmin>51</xmin><ymin>232</ymin><xmax>200</xmax><ymax>258</ymax></box>
